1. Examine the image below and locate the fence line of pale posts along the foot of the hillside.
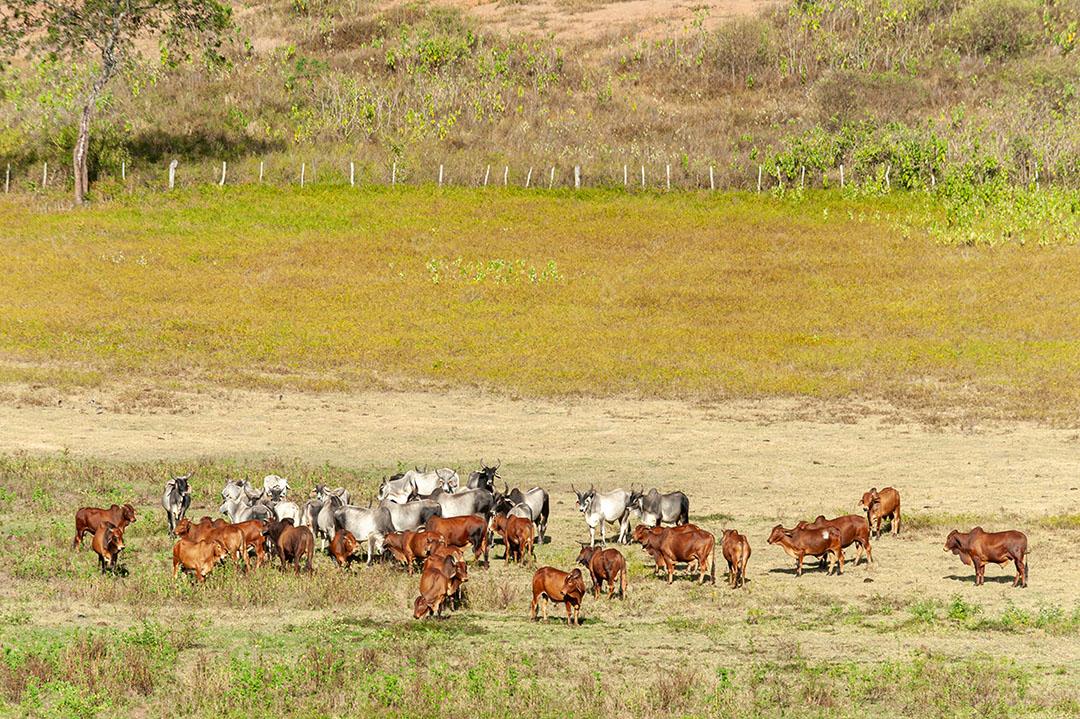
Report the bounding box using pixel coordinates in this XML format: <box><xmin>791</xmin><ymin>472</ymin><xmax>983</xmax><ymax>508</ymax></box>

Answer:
<box><xmin>3</xmin><ymin>157</ymin><xmax>1019</xmax><ymax>193</ymax></box>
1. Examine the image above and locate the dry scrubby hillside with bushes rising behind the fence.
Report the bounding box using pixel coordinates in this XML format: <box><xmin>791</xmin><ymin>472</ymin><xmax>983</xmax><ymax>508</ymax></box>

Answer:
<box><xmin>0</xmin><ymin>0</ymin><xmax>1080</xmax><ymax>192</ymax></box>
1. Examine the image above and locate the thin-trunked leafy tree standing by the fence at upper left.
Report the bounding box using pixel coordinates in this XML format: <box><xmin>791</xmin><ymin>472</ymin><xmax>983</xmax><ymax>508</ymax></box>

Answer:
<box><xmin>0</xmin><ymin>0</ymin><xmax>232</xmax><ymax>204</ymax></box>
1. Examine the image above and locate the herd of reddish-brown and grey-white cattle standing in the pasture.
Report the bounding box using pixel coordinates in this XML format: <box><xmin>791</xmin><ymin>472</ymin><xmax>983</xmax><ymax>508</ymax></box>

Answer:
<box><xmin>72</xmin><ymin>462</ymin><xmax>1027</xmax><ymax>624</ymax></box>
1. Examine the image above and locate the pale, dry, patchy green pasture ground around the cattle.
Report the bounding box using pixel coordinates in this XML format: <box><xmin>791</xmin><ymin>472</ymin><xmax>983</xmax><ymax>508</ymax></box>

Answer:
<box><xmin>0</xmin><ymin>392</ymin><xmax>1080</xmax><ymax>717</ymax></box>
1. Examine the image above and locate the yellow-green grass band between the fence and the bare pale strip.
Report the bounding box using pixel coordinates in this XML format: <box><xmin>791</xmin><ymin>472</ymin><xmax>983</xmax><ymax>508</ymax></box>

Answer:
<box><xmin>0</xmin><ymin>187</ymin><xmax>1080</xmax><ymax>421</ymax></box>
